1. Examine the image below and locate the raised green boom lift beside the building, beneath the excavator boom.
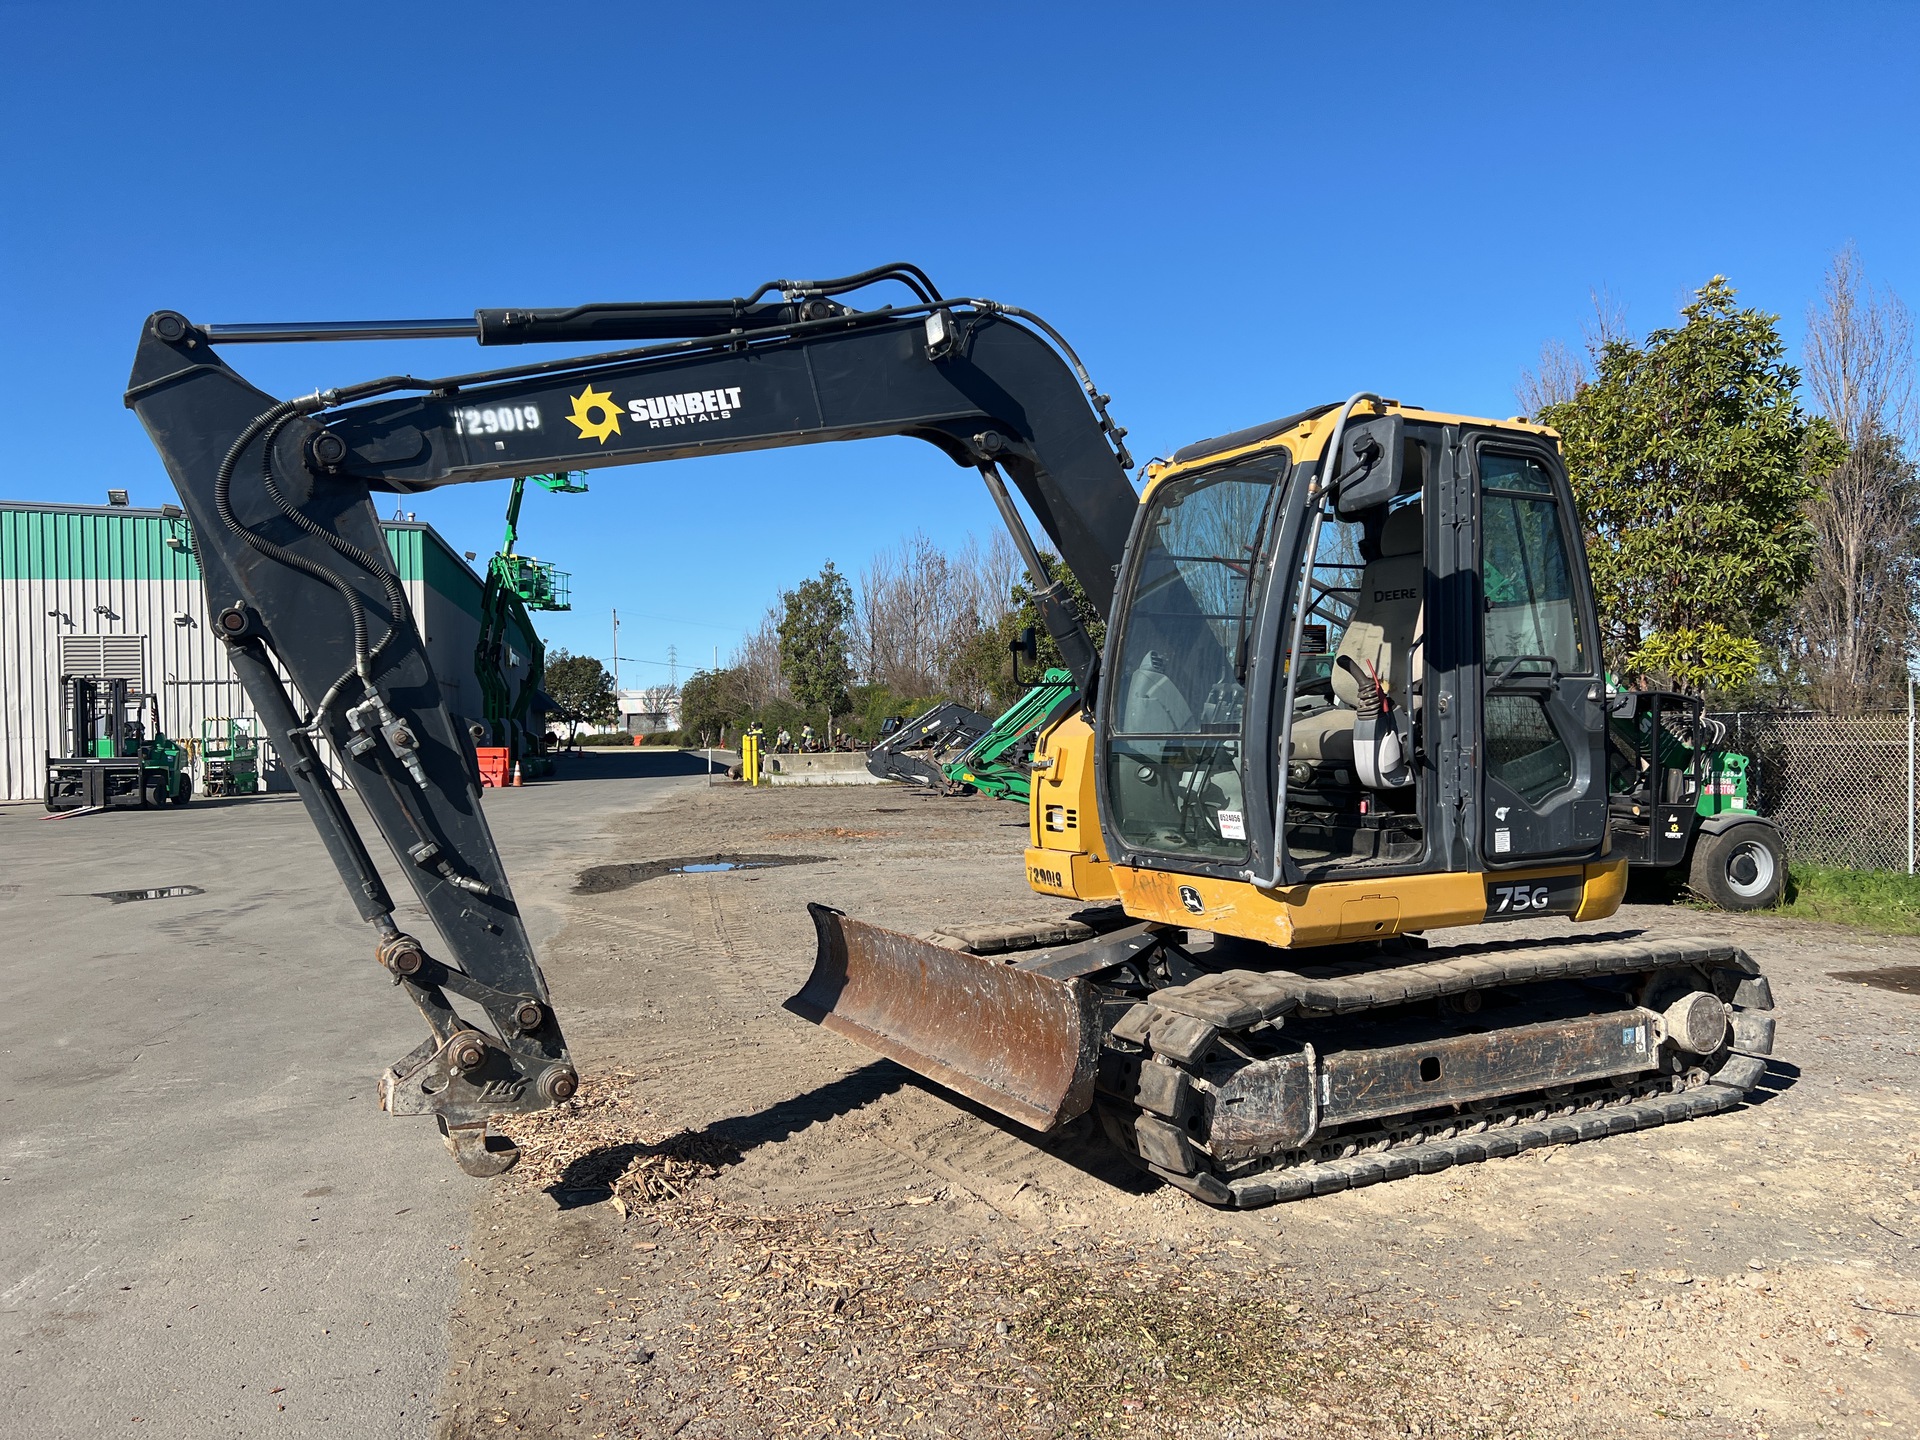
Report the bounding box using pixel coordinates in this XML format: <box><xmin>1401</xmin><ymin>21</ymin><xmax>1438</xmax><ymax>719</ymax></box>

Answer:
<box><xmin>474</xmin><ymin>470</ymin><xmax>586</xmax><ymax>780</ymax></box>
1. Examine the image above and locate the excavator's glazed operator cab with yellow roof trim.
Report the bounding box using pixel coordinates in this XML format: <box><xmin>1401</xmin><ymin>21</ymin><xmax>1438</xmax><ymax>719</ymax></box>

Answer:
<box><xmin>1100</xmin><ymin>403</ymin><xmax>1617</xmax><ymax>945</ymax></box>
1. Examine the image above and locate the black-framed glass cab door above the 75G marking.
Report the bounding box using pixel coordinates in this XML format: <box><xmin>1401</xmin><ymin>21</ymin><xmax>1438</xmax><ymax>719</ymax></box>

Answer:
<box><xmin>1469</xmin><ymin>434</ymin><xmax>1607</xmax><ymax>868</ymax></box>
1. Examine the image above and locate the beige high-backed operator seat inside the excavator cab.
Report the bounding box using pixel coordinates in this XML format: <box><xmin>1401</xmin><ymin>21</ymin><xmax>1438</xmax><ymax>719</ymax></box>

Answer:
<box><xmin>1290</xmin><ymin>505</ymin><xmax>1427</xmax><ymax>768</ymax></box>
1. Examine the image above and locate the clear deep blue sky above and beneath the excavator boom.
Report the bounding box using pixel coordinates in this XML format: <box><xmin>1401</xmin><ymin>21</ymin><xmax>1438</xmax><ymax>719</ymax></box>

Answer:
<box><xmin>0</xmin><ymin>2</ymin><xmax>1920</xmax><ymax>684</ymax></box>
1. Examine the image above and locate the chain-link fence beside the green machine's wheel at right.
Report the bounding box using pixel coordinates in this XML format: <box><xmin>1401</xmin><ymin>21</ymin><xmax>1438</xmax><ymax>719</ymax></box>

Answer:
<box><xmin>1715</xmin><ymin>710</ymin><xmax>1914</xmax><ymax>872</ymax></box>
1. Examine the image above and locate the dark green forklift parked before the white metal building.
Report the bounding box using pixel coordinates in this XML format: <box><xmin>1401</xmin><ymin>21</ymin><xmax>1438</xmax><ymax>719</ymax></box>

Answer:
<box><xmin>46</xmin><ymin>676</ymin><xmax>194</xmax><ymax>814</ymax></box>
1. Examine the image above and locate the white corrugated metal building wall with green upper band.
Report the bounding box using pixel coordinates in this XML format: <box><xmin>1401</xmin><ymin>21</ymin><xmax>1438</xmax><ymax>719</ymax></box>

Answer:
<box><xmin>0</xmin><ymin>501</ymin><xmax>526</xmax><ymax>801</ymax></box>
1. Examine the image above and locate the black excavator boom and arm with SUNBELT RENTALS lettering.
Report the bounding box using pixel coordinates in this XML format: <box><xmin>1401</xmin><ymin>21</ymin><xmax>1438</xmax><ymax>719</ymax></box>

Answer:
<box><xmin>127</xmin><ymin>267</ymin><xmax>1137</xmax><ymax>1175</ymax></box>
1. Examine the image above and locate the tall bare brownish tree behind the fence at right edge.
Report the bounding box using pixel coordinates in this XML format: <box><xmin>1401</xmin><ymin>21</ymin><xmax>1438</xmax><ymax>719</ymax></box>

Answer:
<box><xmin>1789</xmin><ymin>244</ymin><xmax>1920</xmax><ymax>710</ymax></box>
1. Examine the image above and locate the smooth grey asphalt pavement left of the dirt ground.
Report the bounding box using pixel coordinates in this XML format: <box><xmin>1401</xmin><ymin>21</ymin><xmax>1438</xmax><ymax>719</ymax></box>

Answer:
<box><xmin>0</xmin><ymin>751</ymin><xmax>703</xmax><ymax>1440</ymax></box>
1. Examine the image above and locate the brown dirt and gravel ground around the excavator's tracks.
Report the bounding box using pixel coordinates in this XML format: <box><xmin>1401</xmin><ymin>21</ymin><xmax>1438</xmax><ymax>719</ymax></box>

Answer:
<box><xmin>440</xmin><ymin>787</ymin><xmax>1920</xmax><ymax>1440</ymax></box>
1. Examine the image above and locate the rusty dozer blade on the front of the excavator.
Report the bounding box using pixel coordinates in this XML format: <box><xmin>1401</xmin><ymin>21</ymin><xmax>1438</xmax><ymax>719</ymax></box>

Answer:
<box><xmin>787</xmin><ymin>904</ymin><xmax>1100</xmax><ymax>1131</ymax></box>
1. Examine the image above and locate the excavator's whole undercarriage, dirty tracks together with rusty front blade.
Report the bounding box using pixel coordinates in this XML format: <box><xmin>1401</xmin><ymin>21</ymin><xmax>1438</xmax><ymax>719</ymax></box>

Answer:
<box><xmin>789</xmin><ymin>906</ymin><xmax>1774</xmax><ymax>1208</ymax></box>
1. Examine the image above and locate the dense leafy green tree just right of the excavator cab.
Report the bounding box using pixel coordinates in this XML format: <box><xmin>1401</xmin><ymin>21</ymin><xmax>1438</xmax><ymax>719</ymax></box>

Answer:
<box><xmin>1536</xmin><ymin>275</ymin><xmax>1837</xmax><ymax>691</ymax></box>
